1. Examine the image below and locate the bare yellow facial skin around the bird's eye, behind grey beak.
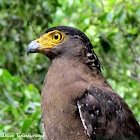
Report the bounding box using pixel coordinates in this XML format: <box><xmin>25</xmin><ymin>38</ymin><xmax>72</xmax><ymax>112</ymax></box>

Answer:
<box><xmin>36</xmin><ymin>30</ymin><xmax>65</xmax><ymax>49</ymax></box>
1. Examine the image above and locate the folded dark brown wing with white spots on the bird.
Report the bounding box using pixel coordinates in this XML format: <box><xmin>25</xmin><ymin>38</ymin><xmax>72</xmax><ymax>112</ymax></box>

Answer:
<box><xmin>77</xmin><ymin>86</ymin><xmax>140</xmax><ymax>140</ymax></box>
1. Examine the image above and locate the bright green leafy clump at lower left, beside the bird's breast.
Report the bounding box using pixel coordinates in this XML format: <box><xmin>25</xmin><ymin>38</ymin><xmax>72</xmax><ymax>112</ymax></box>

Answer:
<box><xmin>0</xmin><ymin>69</ymin><xmax>41</xmax><ymax>139</ymax></box>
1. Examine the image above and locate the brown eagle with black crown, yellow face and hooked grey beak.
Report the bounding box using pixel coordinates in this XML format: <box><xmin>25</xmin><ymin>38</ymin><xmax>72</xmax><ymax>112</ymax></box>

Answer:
<box><xmin>27</xmin><ymin>26</ymin><xmax>140</xmax><ymax>140</ymax></box>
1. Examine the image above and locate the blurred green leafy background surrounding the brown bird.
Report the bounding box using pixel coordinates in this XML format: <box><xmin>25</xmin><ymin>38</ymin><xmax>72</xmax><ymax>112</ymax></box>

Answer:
<box><xmin>0</xmin><ymin>0</ymin><xmax>140</xmax><ymax>140</ymax></box>
